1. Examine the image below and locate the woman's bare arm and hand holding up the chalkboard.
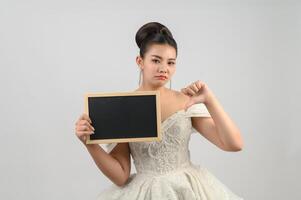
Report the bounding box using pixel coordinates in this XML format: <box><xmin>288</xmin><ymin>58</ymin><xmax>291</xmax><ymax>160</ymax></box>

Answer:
<box><xmin>76</xmin><ymin>114</ymin><xmax>131</xmax><ymax>186</ymax></box>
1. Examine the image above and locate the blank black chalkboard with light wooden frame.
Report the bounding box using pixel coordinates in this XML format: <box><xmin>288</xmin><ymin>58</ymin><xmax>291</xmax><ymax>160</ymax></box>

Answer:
<box><xmin>85</xmin><ymin>91</ymin><xmax>161</xmax><ymax>144</ymax></box>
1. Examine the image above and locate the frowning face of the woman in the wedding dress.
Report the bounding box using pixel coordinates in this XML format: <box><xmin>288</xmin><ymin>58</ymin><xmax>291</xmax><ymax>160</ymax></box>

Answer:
<box><xmin>136</xmin><ymin>44</ymin><xmax>176</xmax><ymax>87</ymax></box>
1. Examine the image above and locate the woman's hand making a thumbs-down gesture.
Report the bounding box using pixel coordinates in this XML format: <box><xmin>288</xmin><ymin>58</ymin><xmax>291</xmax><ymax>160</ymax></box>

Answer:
<box><xmin>181</xmin><ymin>80</ymin><xmax>210</xmax><ymax>111</ymax></box>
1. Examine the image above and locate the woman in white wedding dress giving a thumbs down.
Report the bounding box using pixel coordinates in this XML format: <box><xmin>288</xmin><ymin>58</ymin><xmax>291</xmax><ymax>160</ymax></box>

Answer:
<box><xmin>76</xmin><ymin>22</ymin><xmax>243</xmax><ymax>200</ymax></box>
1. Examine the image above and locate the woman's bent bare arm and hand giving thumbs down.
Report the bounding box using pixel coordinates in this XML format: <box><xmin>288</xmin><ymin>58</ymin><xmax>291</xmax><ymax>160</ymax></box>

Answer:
<box><xmin>182</xmin><ymin>81</ymin><xmax>243</xmax><ymax>151</ymax></box>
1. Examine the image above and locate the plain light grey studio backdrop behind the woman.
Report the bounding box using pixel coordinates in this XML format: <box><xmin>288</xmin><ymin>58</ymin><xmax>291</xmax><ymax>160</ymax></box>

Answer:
<box><xmin>0</xmin><ymin>0</ymin><xmax>301</xmax><ymax>200</ymax></box>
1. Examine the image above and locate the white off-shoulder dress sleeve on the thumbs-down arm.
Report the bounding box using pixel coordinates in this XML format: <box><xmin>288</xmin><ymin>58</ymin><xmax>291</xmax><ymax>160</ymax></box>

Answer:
<box><xmin>186</xmin><ymin>103</ymin><xmax>211</xmax><ymax>133</ymax></box>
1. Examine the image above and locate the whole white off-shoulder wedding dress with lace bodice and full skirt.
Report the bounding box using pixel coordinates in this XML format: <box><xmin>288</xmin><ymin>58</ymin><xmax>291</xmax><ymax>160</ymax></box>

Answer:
<box><xmin>97</xmin><ymin>103</ymin><xmax>243</xmax><ymax>200</ymax></box>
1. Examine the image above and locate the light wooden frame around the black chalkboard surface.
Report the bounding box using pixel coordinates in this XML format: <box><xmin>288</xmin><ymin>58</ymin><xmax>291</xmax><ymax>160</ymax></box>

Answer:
<box><xmin>84</xmin><ymin>91</ymin><xmax>162</xmax><ymax>144</ymax></box>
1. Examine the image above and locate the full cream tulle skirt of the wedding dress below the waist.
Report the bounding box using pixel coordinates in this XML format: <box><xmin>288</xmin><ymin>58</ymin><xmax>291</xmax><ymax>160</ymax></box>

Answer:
<box><xmin>97</xmin><ymin>164</ymin><xmax>243</xmax><ymax>200</ymax></box>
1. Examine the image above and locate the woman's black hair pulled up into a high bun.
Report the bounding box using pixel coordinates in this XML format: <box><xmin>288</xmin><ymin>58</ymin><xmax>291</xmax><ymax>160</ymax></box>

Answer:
<box><xmin>135</xmin><ymin>22</ymin><xmax>178</xmax><ymax>58</ymax></box>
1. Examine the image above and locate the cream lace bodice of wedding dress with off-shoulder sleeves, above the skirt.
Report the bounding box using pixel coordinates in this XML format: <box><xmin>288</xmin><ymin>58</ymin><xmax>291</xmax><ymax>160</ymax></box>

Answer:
<box><xmin>106</xmin><ymin>103</ymin><xmax>211</xmax><ymax>174</ymax></box>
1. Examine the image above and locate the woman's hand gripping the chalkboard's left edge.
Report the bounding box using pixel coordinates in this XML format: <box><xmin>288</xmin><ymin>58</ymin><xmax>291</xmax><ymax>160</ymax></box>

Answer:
<box><xmin>75</xmin><ymin>113</ymin><xmax>95</xmax><ymax>145</ymax></box>
